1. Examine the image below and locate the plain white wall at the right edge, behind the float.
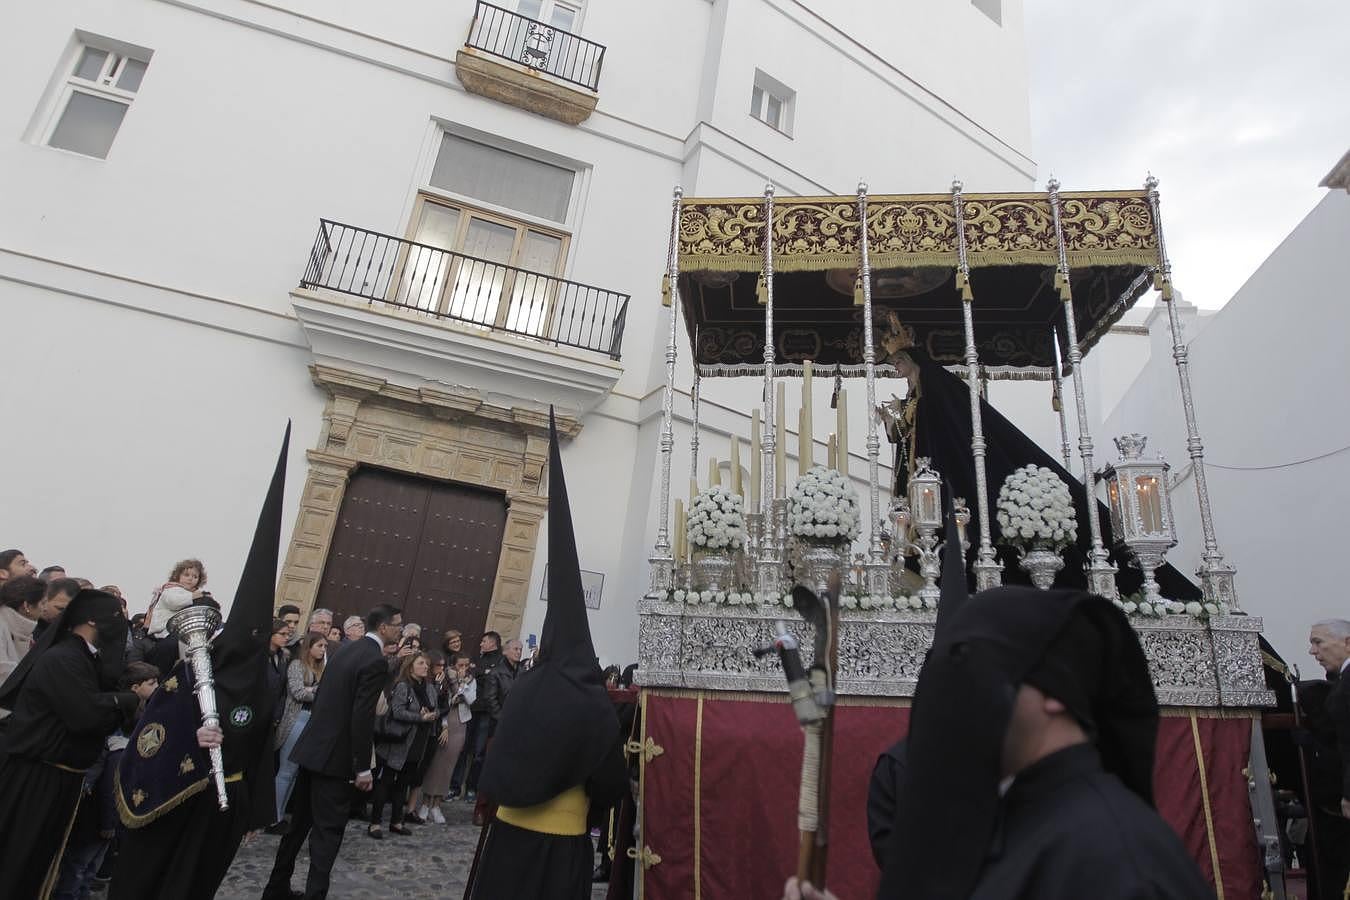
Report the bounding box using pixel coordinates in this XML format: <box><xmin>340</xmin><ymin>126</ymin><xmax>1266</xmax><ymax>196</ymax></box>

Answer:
<box><xmin>1099</xmin><ymin>190</ymin><xmax>1350</xmax><ymax>671</ymax></box>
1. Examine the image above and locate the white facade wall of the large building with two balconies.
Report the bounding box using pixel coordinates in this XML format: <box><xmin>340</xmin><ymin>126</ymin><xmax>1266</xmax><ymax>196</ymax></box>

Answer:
<box><xmin>0</xmin><ymin>0</ymin><xmax>1034</xmax><ymax>660</ymax></box>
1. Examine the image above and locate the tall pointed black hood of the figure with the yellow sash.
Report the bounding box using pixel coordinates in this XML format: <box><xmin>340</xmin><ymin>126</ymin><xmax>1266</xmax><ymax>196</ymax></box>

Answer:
<box><xmin>481</xmin><ymin>409</ymin><xmax>618</xmax><ymax>807</ymax></box>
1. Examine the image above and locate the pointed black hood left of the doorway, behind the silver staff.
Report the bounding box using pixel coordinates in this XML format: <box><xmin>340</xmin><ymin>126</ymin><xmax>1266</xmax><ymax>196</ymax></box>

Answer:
<box><xmin>211</xmin><ymin>422</ymin><xmax>290</xmax><ymax>694</ymax></box>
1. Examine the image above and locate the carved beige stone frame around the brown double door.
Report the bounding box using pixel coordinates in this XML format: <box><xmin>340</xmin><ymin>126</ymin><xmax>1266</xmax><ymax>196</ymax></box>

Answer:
<box><xmin>277</xmin><ymin>364</ymin><xmax>581</xmax><ymax>645</ymax></box>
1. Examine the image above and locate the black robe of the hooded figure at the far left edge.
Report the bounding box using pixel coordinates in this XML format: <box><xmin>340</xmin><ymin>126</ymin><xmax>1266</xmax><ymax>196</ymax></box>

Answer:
<box><xmin>0</xmin><ymin>634</ymin><xmax>138</xmax><ymax>897</ymax></box>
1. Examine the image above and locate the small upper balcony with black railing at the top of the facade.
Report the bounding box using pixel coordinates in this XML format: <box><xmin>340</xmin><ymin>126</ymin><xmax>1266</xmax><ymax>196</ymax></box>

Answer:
<box><xmin>455</xmin><ymin>0</ymin><xmax>605</xmax><ymax>124</ymax></box>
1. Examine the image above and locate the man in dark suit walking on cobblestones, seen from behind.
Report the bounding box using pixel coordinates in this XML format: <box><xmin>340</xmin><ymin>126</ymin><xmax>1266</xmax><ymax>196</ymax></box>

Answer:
<box><xmin>262</xmin><ymin>604</ymin><xmax>404</xmax><ymax>900</ymax></box>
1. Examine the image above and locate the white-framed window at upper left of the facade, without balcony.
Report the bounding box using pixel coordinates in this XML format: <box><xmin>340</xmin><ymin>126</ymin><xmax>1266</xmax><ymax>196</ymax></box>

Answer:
<box><xmin>42</xmin><ymin>36</ymin><xmax>150</xmax><ymax>159</ymax></box>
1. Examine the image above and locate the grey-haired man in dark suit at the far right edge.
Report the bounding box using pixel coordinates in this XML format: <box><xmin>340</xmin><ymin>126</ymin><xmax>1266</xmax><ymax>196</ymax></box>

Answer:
<box><xmin>1308</xmin><ymin>619</ymin><xmax>1350</xmax><ymax>900</ymax></box>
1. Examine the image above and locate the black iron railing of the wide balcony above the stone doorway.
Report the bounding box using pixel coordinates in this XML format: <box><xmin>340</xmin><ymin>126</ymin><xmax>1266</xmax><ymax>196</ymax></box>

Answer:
<box><xmin>300</xmin><ymin>219</ymin><xmax>628</xmax><ymax>360</ymax></box>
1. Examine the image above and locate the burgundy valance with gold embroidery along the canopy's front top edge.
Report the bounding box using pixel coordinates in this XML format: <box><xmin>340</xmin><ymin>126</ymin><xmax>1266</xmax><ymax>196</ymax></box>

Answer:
<box><xmin>679</xmin><ymin>190</ymin><xmax>1158</xmax><ymax>273</ymax></box>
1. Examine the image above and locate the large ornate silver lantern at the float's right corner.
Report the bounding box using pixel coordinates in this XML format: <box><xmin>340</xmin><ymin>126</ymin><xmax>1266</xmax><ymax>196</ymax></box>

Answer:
<box><xmin>1104</xmin><ymin>434</ymin><xmax>1177</xmax><ymax>603</ymax></box>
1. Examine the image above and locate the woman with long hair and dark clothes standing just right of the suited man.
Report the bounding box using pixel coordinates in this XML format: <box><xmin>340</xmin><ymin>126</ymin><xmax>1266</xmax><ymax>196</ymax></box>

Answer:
<box><xmin>367</xmin><ymin>652</ymin><xmax>437</xmax><ymax>841</ymax></box>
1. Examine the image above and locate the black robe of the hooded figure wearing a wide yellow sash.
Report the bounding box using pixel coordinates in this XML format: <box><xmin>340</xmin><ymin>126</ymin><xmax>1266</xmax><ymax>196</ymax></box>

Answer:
<box><xmin>466</xmin><ymin>735</ymin><xmax>628</xmax><ymax>900</ymax></box>
